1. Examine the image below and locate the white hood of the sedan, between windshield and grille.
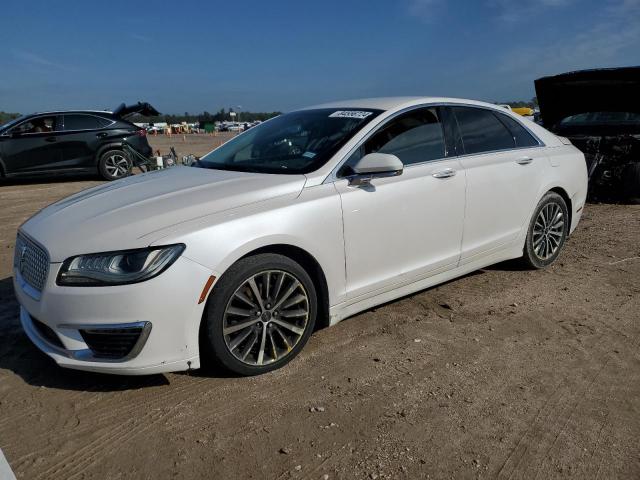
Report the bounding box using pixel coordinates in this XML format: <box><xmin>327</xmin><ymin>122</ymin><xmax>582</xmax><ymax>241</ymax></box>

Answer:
<box><xmin>20</xmin><ymin>167</ymin><xmax>306</xmax><ymax>262</ymax></box>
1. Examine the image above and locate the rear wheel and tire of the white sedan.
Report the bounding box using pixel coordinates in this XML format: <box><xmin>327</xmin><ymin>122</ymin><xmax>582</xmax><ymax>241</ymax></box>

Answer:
<box><xmin>523</xmin><ymin>192</ymin><xmax>569</xmax><ymax>269</ymax></box>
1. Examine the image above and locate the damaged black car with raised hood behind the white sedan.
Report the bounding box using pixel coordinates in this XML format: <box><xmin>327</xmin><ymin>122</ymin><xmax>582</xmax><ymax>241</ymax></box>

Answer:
<box><xmin>535</xmin><ymin>67</ymin><xmax>640</xmax><ymax>203</ymax></box>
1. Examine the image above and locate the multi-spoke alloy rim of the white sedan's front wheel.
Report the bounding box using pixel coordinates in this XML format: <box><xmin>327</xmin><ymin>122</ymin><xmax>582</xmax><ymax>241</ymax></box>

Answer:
<box><xmin>222</xmin><ymin>270</ymin><xmax>309</xmax><ymax>366</ymax></box>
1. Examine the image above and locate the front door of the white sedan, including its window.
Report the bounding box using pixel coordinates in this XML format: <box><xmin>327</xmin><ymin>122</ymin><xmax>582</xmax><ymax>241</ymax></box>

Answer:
<box><xmin>335</xmin><ymin>108</ymin><xmax>465</xmax><ymax>299</ymax></box>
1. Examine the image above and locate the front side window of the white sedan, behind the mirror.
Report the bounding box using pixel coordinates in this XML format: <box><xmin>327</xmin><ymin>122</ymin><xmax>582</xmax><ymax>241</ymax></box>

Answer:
<box><xmin>339</xmin><ymin>108</ymin><xmax>445</xmax><ymax>176</ymax></box>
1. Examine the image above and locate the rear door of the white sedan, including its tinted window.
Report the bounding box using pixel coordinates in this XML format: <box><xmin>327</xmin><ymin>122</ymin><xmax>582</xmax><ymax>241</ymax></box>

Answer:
<box><xmin>451</xmin><ymin>106</ymin><xmax>548</xmax><ymax>264</ymax></box>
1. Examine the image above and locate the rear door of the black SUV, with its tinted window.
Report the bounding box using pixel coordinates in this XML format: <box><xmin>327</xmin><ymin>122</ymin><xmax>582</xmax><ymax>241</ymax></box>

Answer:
<box><xmin>58</xmin><ymin>113</ymin><xmax>107</xmax><ymax>168</ymax></box>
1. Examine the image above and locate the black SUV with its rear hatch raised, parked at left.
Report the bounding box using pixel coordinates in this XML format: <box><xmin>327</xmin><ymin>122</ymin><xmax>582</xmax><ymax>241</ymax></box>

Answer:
<box><xmin>0</xmin><ymin>102</ymin><xmax>159</xmax><ymax>180</ymax></box>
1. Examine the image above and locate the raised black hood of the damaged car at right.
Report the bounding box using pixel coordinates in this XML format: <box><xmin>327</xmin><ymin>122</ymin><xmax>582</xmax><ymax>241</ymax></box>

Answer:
<box><xmin>535</xmin><ymin>67</ymin><xmax>640</xmax><ymax>129</ymax></box>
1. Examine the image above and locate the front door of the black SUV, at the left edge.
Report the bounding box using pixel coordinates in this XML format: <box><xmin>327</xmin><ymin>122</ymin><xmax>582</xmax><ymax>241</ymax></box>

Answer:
<box><xmin>2</xmin><ymin>115</ymin><xmax>61</xmax><ymax>174</ymax></box>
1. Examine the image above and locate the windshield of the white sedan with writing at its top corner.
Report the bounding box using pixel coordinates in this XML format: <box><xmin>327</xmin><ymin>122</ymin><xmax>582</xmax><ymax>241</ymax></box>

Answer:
<box><xmin>196</xmin><ymin>108</ymin><xmax>382</xmax><ymax>174</ymax></box>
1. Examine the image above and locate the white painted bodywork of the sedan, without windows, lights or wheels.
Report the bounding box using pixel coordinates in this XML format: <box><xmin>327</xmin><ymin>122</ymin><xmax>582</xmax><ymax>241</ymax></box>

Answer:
<box><xmin>14</xmin><ymin>97</ymin><xmax>587</xmax><ymax>374</ymax></box>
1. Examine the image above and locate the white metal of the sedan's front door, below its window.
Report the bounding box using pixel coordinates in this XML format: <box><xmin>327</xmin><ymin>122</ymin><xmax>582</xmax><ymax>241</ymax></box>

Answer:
<box><xmin>335</xmin><ymin>159</ymin><xmax>465</xmax><ymax>299</ymax></box>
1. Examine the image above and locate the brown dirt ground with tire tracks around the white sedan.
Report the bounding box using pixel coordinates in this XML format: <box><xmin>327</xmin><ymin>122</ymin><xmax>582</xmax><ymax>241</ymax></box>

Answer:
<box><xmin>0</xmin><ymin>137</ymin><xmax>640</xmax><ymax>479</ymax></box>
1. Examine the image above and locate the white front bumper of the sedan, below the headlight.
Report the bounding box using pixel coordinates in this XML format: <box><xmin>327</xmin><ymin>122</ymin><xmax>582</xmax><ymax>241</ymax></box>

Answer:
<box><xmin>14</xmin><ymin>257</ymin><xmax>211</xmax><ymax>375</ymax></box>
